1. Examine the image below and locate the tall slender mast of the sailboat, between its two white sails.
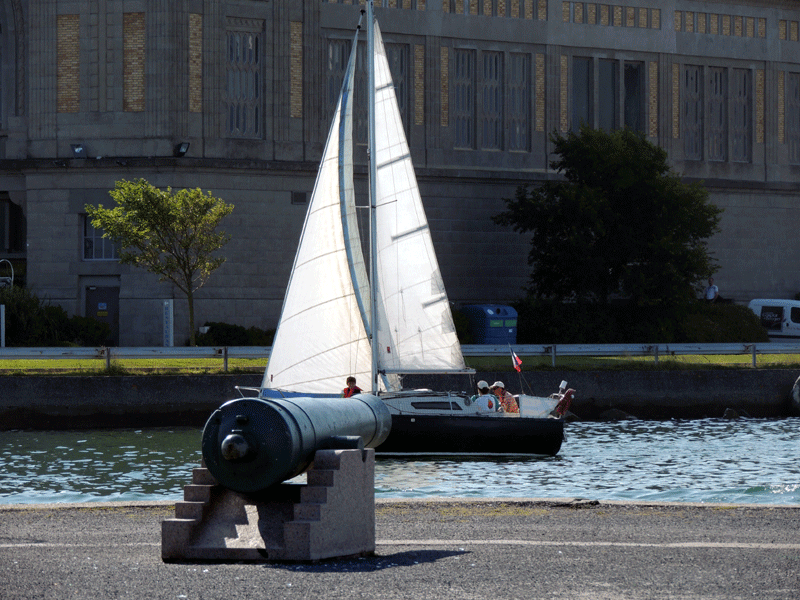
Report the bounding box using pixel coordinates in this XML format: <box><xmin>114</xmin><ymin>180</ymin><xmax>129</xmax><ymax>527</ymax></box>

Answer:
<box><xmin>367</xmin><ymin>0</ymin><xmax>378</xmax><ymax>394</ymax></box>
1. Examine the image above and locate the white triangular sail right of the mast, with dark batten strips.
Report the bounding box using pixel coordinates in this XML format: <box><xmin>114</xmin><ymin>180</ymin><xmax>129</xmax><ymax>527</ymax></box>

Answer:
<box><xmin>374</xmin><ymin>23</ymin><xmax>465</xmax><ymax>372</ymax></box>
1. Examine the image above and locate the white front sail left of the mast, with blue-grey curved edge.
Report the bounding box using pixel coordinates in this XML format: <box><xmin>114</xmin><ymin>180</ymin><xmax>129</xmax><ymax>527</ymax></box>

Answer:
<box><xmin>262</xmin><ymin>35</ymin><xmax>372</xmax><ymax>394</ymax></box>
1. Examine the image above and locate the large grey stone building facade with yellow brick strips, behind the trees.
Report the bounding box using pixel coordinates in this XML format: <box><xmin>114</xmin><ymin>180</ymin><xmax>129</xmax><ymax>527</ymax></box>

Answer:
<box><xmin>0</xmin><ymin>0</ymin><xmax>800</xmax><ymax>346</ymax></box>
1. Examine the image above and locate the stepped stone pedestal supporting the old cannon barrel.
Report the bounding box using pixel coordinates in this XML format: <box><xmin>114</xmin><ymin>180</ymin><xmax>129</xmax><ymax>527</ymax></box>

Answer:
<box><xmin>161</xmin><ymin>448</ymin><xmax>375</xmax><ymax>562</ymax></box>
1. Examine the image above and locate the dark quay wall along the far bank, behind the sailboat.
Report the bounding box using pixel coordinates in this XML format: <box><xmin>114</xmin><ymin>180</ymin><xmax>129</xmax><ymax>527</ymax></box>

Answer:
<box><xmin>0</xmin><ymin>369</ymin><xmax>800</xmax><ymax>430</ymax></box>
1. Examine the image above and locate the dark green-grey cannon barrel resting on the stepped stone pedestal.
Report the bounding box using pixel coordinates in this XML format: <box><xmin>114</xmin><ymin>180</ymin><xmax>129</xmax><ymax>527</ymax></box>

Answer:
<box><xmin>202</xmin><ymin>394</ymin><xmax>392</xmax><ymax>493</ymax></box>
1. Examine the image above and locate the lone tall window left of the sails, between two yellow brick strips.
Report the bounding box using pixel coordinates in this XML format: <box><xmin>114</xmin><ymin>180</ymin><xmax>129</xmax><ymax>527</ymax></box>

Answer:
<box><xmin>225</xmin><ymin>30</ymin><xmax>264</xmax><ymax>139</ymax></box>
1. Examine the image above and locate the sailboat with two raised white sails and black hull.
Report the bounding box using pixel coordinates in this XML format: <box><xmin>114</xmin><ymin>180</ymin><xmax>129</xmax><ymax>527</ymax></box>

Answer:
<box><xmin>250</xmin><ymin>0</ymin><xmax>565</xmax><ymax>455</ymax></box>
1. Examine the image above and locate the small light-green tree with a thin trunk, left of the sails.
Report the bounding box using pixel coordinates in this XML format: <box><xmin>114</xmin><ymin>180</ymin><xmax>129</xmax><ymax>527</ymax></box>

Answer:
<box><xmin>86</xmin><ymin>179</ymin><xmax>233</xmax><ymax>346</ymax></box>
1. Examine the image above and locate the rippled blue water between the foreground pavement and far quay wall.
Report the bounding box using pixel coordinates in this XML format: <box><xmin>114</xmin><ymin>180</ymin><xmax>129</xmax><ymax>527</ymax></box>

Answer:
<box><xmin>0</xmin><ymin>418</ymin><xmax>800</xmax><ymax>504</ymax></box>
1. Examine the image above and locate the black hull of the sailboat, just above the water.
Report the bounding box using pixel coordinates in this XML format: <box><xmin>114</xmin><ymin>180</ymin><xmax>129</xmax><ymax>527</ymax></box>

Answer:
<box><xmin>376</xmin><ymin>415</ymin><xmax>564</xmax><ymax>456</ymax></box>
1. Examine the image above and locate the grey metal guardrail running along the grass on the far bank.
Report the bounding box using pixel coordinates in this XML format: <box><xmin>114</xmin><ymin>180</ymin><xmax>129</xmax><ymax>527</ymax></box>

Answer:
<box><xmin>0</xmin><ymin>341</ymin><xmax>800</xmax><ymax>372</ymax></box>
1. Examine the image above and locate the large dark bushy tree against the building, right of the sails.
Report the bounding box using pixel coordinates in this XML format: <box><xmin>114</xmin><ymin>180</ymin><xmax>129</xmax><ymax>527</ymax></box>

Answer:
<box><xmin>493</xmin><ymin>126</ymin><xmax>722</xmax><ymax>306</ymax></box>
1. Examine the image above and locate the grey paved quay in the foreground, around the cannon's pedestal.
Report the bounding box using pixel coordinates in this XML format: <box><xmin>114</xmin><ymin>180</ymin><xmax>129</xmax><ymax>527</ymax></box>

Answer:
<box><xmin>0</xmin><ymin>499</ymin><xmax>800</xmax><ymax>600</ymax></box>
